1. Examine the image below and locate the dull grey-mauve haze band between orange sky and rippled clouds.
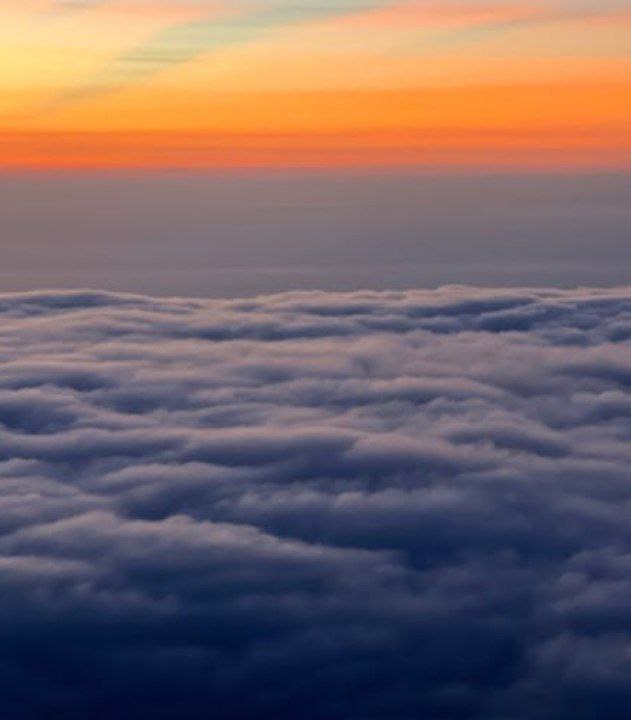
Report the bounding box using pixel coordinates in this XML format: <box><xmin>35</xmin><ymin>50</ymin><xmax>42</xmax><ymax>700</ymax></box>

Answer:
<box><xmin>0</xmin><ymin>171</ymin><xmax>631</xmax><ymax>297</ymax></box>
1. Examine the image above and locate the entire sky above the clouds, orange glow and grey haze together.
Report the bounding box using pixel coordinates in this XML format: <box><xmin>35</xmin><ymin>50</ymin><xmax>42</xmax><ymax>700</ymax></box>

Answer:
<box><xmin>0</xmin><ymin>0</ymin><xmax>631</xmax><ymax>297</ymax></box>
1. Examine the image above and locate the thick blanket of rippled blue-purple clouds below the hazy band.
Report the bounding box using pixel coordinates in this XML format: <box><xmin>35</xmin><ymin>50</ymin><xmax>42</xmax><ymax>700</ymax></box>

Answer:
<box><xmin>0</xmin><ymin>288</ymin><xmax>631</xmax><ymax>720</ymax></box>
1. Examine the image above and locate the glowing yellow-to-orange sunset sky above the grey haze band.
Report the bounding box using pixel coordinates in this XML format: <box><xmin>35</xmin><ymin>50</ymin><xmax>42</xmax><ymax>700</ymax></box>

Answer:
<box><xmin>0</xmin><ymin>0</ymin><xmax>631</xmax><ymax>170</ymax></box>
